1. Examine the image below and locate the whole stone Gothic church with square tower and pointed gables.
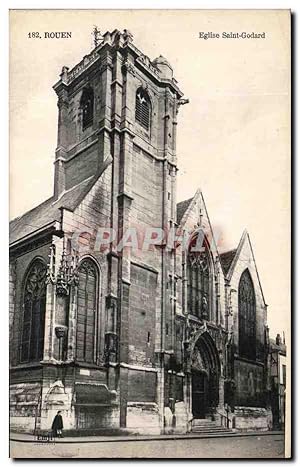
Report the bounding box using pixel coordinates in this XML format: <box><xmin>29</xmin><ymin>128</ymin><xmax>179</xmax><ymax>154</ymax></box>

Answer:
<box><xmin>10</xmin><ymin>30</ymin><xmax>271</xmax><ymax>434</ymax></box>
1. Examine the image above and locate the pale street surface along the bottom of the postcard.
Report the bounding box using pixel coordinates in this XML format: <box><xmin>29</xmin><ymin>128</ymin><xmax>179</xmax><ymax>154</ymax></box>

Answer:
<box><xmin>10</xmin><ymin>434</ymin><xmax>284</xmax><ymax>458</ymax></box>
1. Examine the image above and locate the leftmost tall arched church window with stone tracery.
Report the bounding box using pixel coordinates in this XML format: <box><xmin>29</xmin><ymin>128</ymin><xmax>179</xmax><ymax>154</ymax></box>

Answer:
<box><xmin>21</xmin><ymin>259</ymin><xmax>47</xmax><ymax>362</ymax></box>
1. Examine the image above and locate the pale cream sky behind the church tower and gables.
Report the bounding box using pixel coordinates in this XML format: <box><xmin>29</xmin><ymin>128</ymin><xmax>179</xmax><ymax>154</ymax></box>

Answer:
<box><xmin>10</xmin><ymin>10</ymin><xmax>290</xmax><ymax>336</ymax></box>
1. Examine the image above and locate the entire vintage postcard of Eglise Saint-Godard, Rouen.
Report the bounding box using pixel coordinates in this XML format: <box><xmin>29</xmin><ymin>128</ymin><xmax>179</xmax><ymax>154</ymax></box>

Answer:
<box><xmin>9</xmin><ymin>10</ymin><xmax>291</xmax><ymax>459</ymax></box>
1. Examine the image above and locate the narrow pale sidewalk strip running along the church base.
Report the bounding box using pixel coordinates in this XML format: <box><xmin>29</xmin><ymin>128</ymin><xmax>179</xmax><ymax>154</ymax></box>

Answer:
<box><xmin>10</xmin><ymin>431</ymin><xmax>284</xmax><ymax>444</ymax></box>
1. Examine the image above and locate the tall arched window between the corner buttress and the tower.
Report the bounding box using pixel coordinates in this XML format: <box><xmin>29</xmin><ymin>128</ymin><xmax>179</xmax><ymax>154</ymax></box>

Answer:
<box><xmin>76</xmin><ymin>258</ymin><xmax>98</xmax><ymax>363</ymax></box>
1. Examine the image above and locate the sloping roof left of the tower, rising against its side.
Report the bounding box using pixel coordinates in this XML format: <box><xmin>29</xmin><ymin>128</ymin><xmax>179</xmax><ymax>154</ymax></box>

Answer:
<box><xmin>9</xmin><ymin>156</ymin><xmax>112</xmax><ymax>244</ymax></box>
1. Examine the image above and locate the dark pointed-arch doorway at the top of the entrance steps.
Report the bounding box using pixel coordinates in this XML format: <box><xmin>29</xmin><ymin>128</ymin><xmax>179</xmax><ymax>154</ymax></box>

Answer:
<box><xmin>191</xmin><ymin>332</ymin><xmax>220</xmax><ymax>418</ymax></box>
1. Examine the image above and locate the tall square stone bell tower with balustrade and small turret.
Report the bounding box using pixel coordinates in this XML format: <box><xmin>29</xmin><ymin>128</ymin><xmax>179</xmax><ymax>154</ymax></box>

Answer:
<box><xmin>54</xmin><ymin>30</ymin><xmax>187</xmax><ymax>436</ymax></box>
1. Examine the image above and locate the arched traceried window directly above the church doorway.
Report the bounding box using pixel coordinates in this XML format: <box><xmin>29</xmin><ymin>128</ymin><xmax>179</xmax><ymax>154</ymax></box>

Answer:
<box><xmin>187</xmin><ymin>238</ymin><xmax>211</xmax><ymax>319</ymax></box>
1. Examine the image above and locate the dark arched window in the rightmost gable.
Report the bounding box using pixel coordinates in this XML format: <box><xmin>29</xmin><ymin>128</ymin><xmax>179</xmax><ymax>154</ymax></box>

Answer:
<box><xmin>239</xmin><ymin>269</ymin><xmax>256</xmax><ymax>359</ymax></box>
